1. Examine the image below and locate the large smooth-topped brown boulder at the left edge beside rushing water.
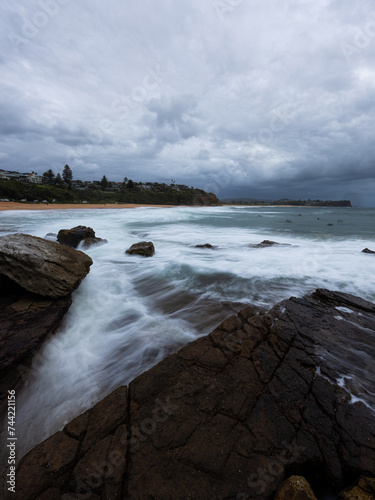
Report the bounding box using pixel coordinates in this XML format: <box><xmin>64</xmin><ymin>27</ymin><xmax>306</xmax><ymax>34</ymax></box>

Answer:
<box><xmin>0</xmin><ymin>233</ymin><xmax>92</xmax><ymax>298</ymax></box>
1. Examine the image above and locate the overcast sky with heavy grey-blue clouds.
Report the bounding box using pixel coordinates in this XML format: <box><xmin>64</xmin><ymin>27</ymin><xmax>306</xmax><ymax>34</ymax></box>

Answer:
<box><xmin>0</xmin><ymin>0</ymin><xmax>375</xmax><ymax>206</ymax></box>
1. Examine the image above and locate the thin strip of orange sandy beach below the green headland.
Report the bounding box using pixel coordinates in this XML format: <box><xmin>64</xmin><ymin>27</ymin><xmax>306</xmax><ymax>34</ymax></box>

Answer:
<box><xmin>0</xmin><ymin>201</ymin><xmax>176</xmax><ymax>212</ymax></box>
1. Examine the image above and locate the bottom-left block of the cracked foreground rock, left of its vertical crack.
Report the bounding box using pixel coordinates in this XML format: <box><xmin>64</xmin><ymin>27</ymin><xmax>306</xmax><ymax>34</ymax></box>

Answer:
<box><xmin>6</xmin><ymin>388</ymin><xmax>128</xmax><ymax>500</ymax></box>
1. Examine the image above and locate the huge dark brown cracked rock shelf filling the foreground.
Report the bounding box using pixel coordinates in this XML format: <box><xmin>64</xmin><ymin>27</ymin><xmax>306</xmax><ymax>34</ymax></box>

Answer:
<box><xmin>6</xmin><ymin>290</ymin><xmax>375</xmax><ymax>500</ymax></box>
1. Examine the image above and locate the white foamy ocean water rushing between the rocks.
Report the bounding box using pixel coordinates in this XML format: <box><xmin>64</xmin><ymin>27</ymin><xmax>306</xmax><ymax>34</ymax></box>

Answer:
<box><xmin>0</xmin><ymin>207</ymin><xmax>375</xmax><ymax>457</ymax></box>
